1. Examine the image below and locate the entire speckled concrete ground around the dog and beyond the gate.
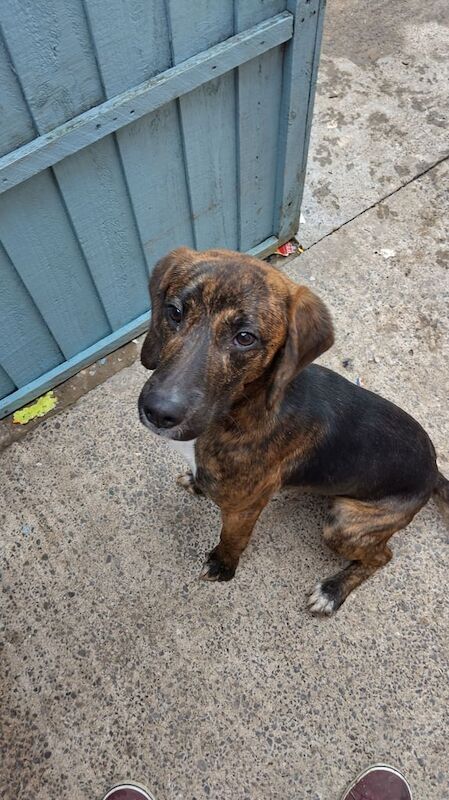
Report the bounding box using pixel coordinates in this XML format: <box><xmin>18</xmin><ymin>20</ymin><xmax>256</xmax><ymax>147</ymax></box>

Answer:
<box><xmin>0</xmin><ymin>0</ymin><xmax>449</xmax><ymax>800</ymax></box>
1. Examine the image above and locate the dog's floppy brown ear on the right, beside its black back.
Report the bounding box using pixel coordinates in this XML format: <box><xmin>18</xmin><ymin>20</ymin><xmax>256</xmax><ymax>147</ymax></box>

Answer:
<box><xmin>268</xmin><ymin>286</ymin><xmax>334</xmax><ymax>408</ymax></box>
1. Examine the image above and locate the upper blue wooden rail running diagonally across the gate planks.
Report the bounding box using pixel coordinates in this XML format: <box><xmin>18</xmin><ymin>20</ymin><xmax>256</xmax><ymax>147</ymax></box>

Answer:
<box><xmin>0</xmin><ymin>11</ymin><xmax>293</xmax><ymax>193</ymax></box>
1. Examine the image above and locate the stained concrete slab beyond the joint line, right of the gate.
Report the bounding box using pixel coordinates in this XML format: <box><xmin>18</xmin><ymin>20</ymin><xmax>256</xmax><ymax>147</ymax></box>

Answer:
<box><xmin>300</xmin><ymin>0</ymin><xmax>449</xmax><ymax>246</ymax></box>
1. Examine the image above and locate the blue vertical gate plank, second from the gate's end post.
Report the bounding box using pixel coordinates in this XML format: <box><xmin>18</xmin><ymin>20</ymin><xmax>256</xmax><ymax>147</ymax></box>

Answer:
<box><xmin>167</xmin><ymin>0</ymin><xmax>238</xmax><ymax>249</ymax></box>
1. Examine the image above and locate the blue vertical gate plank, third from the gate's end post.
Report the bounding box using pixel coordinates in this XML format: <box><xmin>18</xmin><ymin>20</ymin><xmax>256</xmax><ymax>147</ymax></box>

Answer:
<box><xmin>86</xmin><ymin>0</ymin><xmax>193</xmax><ymax>268</ymax></box>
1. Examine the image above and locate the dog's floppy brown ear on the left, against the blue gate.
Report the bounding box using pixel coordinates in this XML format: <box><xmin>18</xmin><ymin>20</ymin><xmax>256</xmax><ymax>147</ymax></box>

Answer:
<box><xmin>140</xmin><ymin>247</ymin><xmax>194</xmax><ymax>369</ymax></box>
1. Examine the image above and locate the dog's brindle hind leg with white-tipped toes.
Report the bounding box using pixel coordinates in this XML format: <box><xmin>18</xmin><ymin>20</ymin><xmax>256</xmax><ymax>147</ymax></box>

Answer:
<box><xmin>309</xmin><ymin>497</ymin><xmax>428</xmax><ymax>615</ymax></box>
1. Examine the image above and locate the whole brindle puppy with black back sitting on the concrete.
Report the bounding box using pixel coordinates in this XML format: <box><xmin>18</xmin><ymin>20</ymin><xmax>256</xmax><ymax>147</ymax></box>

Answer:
<box><xmin>139</xmin><ymin>248</ymin><xmax>449</xmax><ymax>614</ymax></box>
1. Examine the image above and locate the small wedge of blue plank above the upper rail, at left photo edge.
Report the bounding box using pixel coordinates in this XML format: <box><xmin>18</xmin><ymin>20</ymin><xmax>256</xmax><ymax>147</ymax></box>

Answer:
<box><xmin>0</xmin><ymin>34</ymin><xmax>35</xmax><ymax>157</ymax></box>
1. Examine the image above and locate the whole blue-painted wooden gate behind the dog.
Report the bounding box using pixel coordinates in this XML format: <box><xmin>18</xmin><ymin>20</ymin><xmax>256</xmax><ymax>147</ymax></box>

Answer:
<box><xmin>0</xmin><ymin>0</ymin><xmax>324</xmax><ymax>416</ymax></box>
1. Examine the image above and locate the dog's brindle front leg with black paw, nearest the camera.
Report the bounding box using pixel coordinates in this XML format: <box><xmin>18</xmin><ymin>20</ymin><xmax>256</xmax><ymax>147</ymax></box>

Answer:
<box><xmin>201</xmin><ymin>497</ymin><xmax>269</xmax><ymax>581</ymax></box>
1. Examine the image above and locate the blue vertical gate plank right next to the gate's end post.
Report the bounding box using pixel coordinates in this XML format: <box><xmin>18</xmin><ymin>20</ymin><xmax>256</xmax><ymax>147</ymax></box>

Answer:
<box><xmin>235</xmin><ymin>0</ymin><xmax>285</xmax><ymax>250</ymax></box>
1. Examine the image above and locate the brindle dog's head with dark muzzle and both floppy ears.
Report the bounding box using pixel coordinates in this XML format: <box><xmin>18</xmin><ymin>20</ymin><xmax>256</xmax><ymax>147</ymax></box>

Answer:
<box><xmin>139</xmin><ymin>247</ymin><xmax>333</xmax><ymax>440</ymax></box>
